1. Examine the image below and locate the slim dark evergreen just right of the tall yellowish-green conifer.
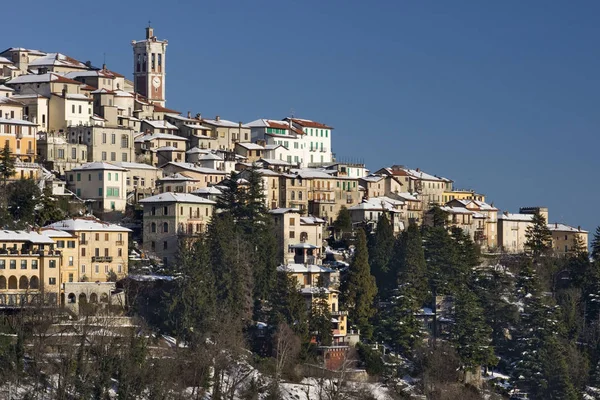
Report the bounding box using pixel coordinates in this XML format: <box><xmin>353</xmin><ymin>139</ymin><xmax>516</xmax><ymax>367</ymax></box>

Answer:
<box><xmin>369</xmin><ymin>212</ymin><xmax>395</xmax><ymax>298</ymax></box>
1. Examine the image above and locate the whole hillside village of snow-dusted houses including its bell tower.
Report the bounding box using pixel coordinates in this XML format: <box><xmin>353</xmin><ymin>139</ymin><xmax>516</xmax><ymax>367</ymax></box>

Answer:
<box><xmin>0</xmin><ymin>27</ymin><xmax>588</xmax><ymax>398</ymax></box>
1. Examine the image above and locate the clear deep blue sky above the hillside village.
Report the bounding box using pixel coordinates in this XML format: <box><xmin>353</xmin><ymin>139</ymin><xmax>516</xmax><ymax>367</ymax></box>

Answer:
<box><xmin>0</xmin><ymin>0</ymin><xmax>600</xmax><ymax>233</ymax></box>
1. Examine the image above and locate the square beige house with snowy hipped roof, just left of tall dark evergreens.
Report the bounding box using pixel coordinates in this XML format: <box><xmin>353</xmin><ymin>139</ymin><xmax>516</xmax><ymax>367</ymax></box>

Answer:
<box><xmin>140</xmin><ymin>192</ymin><xmax>216</xmax><ymax>264</ymax></box>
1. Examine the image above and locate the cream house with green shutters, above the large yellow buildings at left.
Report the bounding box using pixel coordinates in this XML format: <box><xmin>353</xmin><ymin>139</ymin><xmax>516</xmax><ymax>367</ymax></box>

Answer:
<box><xmin>67</xmin><ymin>162</ymin><xmax>128</xmax><ymax>214</ymax></box>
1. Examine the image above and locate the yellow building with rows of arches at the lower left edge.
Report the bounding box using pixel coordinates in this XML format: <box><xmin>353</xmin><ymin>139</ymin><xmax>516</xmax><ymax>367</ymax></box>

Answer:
<box><xmin>0</xmin><ymin>230</ymin><xmax>62</xmax><ymax>307</ymax></box>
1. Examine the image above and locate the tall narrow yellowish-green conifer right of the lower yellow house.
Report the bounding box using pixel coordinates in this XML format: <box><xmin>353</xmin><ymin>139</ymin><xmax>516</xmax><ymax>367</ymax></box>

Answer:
<box><xmin>342</xmin><ymin>229</ymin><xmax>377</xmax><ymax>339</ymax></box>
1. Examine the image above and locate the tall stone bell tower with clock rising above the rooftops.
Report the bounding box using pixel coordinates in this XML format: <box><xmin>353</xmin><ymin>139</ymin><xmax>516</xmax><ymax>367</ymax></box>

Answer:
<box><xmin>131</xmin><ymin>23</ymin><xmax>168</xmax><ymax>107</ymax></box>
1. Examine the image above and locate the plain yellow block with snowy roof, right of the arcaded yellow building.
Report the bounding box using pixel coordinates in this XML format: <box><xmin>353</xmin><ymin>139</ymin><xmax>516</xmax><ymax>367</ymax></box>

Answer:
<box><xmin>44</xmin><ymin>217</ymin><xmax>131</xmax><ymax>282</ymax></box>
